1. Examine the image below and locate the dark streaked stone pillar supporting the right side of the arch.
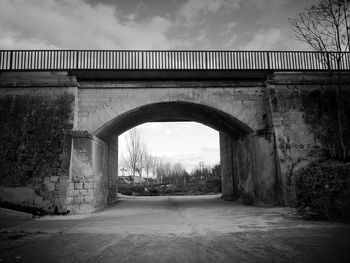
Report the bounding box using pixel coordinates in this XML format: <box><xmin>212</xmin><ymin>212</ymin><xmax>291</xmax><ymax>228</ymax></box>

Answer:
<box><xmin>220</xmin><ymin>131</ymin><xmax>281</xmax><ymax>205</ymax></box>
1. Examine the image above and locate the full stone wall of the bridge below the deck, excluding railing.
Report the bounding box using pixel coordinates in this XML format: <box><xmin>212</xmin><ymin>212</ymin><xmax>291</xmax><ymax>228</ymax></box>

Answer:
<box><xmin>0</xmin><ymin>72</ymin><xmax>350</xmax><ymax>212</ymax></box>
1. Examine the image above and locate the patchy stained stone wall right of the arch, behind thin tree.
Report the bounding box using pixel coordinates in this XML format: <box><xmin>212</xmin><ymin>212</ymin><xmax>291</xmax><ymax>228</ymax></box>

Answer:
<box><xmin>268</xmin><ymin>73</ymin><xmax>350</xmax><ymax>206</ymax></box>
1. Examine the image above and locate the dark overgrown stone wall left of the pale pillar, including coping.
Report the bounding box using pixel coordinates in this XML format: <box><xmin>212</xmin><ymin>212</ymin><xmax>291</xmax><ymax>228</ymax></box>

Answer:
<box><xmin>0</xmin><ymin>79</ymin><xmax>77</xmax><ymax>212</ymax></box>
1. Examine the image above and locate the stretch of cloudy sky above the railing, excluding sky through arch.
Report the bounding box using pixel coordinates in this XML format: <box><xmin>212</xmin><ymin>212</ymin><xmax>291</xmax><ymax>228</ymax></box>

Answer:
<box><xmin>0</xmin><ymin>0</ymin><xmax>308</xmax><ymax>50</ymax></box>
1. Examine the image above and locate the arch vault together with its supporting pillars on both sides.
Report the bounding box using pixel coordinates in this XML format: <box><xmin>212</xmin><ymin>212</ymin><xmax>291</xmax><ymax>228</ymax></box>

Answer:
<box><xmin>70</xmin><ymin>101</ymin><xmax>278</xmax><ymax>214</ymax></box>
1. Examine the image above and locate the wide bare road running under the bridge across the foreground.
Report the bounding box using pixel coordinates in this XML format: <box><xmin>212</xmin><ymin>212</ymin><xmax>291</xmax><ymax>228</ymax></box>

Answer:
<box><xmin>0</xmin><ymin>196</ymin><xmax>350</xmax><ymax>263</ymax></box>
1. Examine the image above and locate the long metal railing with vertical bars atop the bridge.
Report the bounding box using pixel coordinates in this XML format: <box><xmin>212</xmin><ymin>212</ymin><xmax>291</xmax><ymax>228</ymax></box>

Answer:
<box><xmin>0</xmin><ymin>50</ymin><xmax>350</xmax><ymax>71</ymax></box>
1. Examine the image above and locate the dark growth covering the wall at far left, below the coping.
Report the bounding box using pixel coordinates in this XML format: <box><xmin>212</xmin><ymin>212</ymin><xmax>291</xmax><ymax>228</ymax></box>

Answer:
<box><xmin>0</xmin><ymin>94</ymin><xmax>74</xmax><ymax>188</ymax></box>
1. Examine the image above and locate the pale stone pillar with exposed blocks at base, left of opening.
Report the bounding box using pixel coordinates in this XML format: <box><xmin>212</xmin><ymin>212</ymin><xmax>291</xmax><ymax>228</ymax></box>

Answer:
<box><xmin>67</xmin><ymin>131</ymin><xmax>108</xmax><ymax>213</ymax></box>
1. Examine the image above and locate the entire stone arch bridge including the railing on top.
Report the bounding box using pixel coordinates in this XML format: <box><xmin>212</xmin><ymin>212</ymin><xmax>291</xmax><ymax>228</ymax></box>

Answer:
<box><xmin>0</xmin><ymin>51</ymin><xmax>350</xmax><ymax>213</ymax></box>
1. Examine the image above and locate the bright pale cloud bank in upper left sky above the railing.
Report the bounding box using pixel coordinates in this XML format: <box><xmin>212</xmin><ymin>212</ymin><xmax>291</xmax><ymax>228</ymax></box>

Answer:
<box><xmin>0</xmin><ymin>0</ymin><xmax>176</xmax><ymax>49</ymax></box>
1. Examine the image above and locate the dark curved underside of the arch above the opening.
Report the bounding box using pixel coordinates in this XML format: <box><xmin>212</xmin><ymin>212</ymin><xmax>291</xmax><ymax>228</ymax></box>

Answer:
<box><xmin>94</xmin><ymin>101</ymin><xmax>253</xmax><ymax>141</ymax></box>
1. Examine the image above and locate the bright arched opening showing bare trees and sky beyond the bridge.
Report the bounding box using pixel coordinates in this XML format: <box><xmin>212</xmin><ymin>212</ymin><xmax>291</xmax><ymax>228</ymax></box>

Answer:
<box><xmin>118</xmin><ymin>121</ymin><xmax>222</xmax><ymax>196</ymax></box>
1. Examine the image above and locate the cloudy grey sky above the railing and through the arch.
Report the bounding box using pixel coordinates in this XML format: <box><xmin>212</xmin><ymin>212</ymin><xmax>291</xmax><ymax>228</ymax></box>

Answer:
<box><xmin>0</xmin><ymin>0</ymin><xmax>318</xmax><ymax>174</ymax></box>
